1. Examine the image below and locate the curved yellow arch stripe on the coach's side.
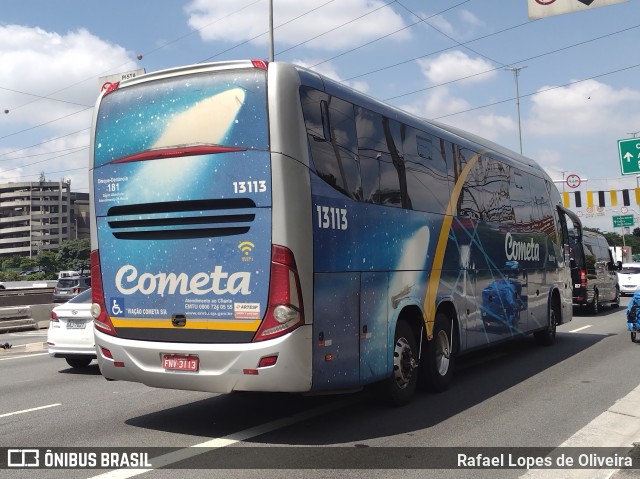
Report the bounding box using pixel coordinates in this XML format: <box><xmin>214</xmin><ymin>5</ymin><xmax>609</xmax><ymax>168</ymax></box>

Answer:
<box><xmin>423</xmin><ymin>151</ymin><xmax>486</xmax><ymax>339</ymax></box>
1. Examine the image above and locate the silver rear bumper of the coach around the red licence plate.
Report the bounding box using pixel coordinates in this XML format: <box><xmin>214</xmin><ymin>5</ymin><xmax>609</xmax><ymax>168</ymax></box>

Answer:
<box><xmin>95</xmin><ymin>325</ymin><xmax>311</xmax><ymax>393</ymax></box>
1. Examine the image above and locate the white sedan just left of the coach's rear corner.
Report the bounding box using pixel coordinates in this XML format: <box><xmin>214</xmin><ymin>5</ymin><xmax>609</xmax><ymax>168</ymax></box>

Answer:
<box><xmin>47</xmin><ymin>289</ymin><xmax>96</xmax><ymax>368</ymax></box>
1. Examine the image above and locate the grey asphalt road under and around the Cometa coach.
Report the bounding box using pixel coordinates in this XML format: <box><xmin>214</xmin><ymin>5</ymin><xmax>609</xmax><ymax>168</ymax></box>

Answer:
<box><xmin>0</xmin><ymin>300</ymin><xmax>640</xmax><ymax>479</ymax></box>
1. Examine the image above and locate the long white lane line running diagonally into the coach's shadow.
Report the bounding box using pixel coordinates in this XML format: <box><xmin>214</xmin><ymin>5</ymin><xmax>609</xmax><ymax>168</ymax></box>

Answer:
<box><xmin>89</xmin><ymin>397</ymin><xmax>362</xmax><ymax>479</ymax></box>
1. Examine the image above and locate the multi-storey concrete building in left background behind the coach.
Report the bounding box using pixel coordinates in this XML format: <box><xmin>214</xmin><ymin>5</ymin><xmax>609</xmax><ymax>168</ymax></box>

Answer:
<box><xmin>0</xmin><ymin>180</ymin><xmax>89</xmax><ymax>258</ymax></box>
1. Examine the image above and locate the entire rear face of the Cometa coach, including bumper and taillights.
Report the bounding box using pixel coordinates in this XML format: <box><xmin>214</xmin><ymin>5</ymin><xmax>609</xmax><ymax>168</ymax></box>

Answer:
<box><xmin>92</xmin><ymin>62</ymin><xmax>310</xmax><ymax>392</ymax></box>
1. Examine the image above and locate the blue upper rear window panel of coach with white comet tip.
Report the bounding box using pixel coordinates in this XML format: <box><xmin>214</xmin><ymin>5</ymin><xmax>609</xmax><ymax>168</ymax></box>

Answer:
<box><xmin>94</xmin><ymin>69</ymin><xmax>269</xmax><ymax>166</ymax></box>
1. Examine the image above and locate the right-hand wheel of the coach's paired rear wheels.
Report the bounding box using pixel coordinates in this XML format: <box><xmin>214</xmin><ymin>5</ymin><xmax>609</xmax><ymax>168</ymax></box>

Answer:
<box><xmin>420</xmin><ymin>313</ymin><xmax>457</xmax><ymax>393</ymax></box>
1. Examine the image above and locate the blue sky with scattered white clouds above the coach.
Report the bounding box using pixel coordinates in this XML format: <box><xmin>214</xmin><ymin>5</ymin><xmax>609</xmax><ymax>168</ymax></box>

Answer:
<box><xmin>0</xmin><ymin>0</ymin><xmax>640</xmax><ymax>233</ymax></box>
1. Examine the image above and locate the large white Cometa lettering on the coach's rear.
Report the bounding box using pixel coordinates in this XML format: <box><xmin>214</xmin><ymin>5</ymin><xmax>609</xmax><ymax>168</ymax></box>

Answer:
<box><xmin>115</xmin><ymin>264</ymin><xmax>251</xmax><ymax>295</ymax></box>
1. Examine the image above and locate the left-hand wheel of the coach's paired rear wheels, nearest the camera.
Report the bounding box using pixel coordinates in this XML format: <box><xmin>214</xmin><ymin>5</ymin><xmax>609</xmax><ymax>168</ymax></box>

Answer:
<box><xmin>383</xmin><ymin>321</ymin><xmax>418</xmax><ymax>407</ymax></box>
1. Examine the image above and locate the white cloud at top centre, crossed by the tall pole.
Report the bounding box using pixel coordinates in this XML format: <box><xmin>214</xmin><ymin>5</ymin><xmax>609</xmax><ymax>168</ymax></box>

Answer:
<box><xmin>185</xmin><ymin>0</ymin><xmax>409</xmax><ymax>53</ymax></box>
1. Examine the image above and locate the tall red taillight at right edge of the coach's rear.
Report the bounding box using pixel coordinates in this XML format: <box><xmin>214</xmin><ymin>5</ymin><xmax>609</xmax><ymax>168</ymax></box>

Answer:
<box><xmin>253</xmin><ymin>245</ymin><xmax>304</xmax><ymax>342</ymax></box>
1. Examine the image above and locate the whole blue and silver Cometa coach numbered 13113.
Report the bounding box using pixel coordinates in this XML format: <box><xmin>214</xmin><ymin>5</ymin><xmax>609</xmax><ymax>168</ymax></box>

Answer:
<box><xmin>90</xmin><ymin>61</ymin><xmax>579</xmax><ymax>405</ymax></box>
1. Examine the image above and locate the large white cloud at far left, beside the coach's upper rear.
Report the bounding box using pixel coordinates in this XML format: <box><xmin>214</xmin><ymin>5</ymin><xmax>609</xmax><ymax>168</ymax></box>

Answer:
<box><xmin>0</xmin><ymin>25</ymin><xmax>132</xmax><ymax>131</ymax></box>
